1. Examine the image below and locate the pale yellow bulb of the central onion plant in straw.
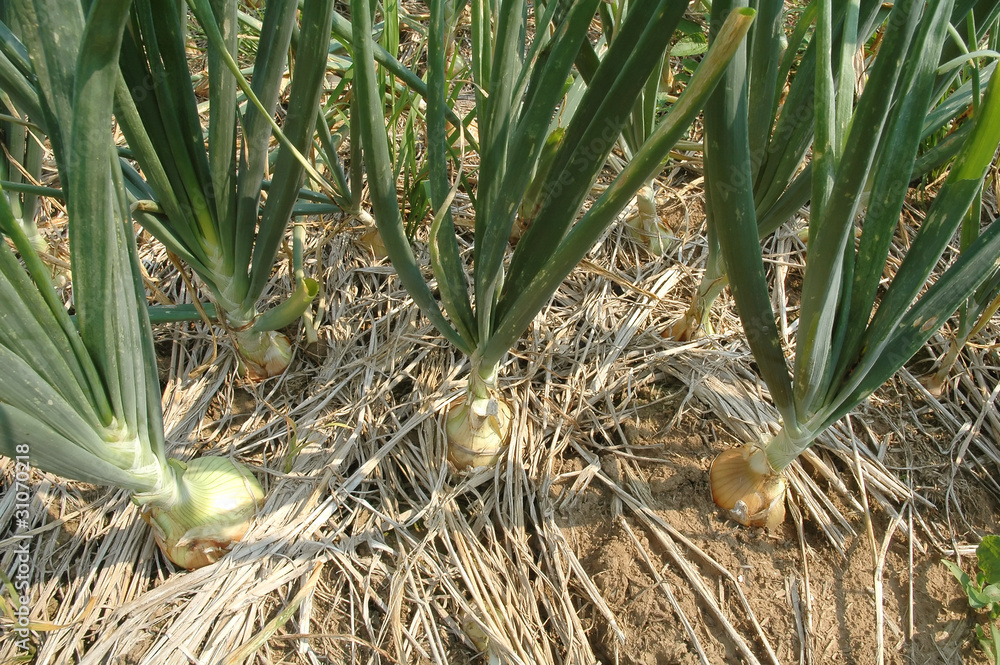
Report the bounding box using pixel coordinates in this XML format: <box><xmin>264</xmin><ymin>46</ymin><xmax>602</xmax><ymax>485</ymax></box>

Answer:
<box><xmin>446</xmin><ymin>396</ymin><xmax>513</xmax><ymax>471</ymax></box>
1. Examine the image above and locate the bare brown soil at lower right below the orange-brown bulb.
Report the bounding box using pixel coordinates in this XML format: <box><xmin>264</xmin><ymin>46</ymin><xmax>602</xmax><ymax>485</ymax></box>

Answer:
<box><xmin>557</xmin><ymin>384</ymin><xmax>997</xmax><ymax>665</ymax></box>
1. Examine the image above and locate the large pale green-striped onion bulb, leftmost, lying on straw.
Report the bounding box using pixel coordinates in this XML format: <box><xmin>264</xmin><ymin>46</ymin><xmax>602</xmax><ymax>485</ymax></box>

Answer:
<box><xmin>134</xmin><ymin>457</ymin><xmax>264</xmax><ymax>570</ymax></box>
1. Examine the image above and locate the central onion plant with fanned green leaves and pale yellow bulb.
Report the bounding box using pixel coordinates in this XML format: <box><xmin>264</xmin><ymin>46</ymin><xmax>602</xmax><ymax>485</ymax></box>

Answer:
<box><xmin>351</xmin><ymin>0</ymin><xmax>753</xmax><ymax>468</ymax></box>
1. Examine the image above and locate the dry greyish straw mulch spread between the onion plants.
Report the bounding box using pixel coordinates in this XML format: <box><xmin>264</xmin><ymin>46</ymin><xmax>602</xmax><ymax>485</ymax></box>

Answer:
<box><xmin>0</xmin><ymin>172</ymin><xmax>1000</xmax><ymax>665</ymax></box>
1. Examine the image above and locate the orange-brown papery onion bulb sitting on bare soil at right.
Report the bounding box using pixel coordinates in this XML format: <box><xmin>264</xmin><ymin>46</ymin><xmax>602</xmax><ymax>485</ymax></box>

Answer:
<box><xmin>709</xmin><ymin>445</ymin><xmax>787</xmax><ymax>529</ymax></box>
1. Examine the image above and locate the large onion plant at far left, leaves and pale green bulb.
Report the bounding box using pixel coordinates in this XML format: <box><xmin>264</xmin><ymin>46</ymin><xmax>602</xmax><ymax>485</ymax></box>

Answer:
<box><xmin>0</xmin><ymin>0</ymin><xmax>263</xmax><ymax>568</ymax></box>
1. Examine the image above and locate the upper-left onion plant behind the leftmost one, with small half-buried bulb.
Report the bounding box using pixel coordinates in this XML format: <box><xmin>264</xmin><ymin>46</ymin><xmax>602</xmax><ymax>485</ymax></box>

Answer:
<box><xmin>115</xmin><ymin>0</ymin><xmax>334</xmax><ymax>378</ymax></box>
